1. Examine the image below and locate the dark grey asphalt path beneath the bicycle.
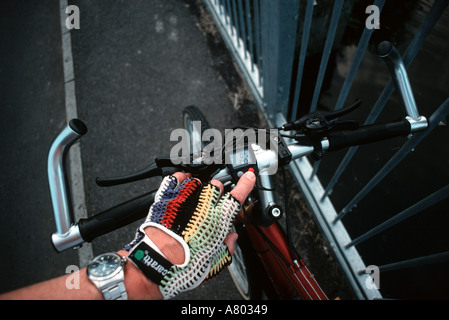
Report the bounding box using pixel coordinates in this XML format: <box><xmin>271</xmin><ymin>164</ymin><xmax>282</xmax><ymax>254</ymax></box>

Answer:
<box><xmin>0</xmin><ymin>0</ymin><xmax>259</xmax><ymax>299</ymax></box>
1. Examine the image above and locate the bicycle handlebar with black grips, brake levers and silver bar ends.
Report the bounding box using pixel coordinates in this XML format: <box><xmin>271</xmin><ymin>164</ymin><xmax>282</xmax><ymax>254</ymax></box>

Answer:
<box><xmin>48</xmin><ymin>42</ymin><xmax>428</xmax><ymax>252</ymax></box>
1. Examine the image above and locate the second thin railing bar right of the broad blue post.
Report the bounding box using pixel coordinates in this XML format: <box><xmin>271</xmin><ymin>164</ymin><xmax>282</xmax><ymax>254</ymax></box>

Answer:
<box><xmin>310</xmin><ymin>0</ymin><xmax>344</xmax><ymax>112</ymax></box>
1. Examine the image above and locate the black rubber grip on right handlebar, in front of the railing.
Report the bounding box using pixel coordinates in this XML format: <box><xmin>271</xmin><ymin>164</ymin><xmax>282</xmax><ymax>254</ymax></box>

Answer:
<box><xmin>328</xmin><ymin>119</ymin><xmax>411</xmax><ymax>151</ymax></box>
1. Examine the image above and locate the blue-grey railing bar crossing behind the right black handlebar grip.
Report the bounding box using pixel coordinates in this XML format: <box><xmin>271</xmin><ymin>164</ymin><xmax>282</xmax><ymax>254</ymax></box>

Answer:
<box><xmin>322</xmin><ymin>0</ymin><xmax>448</xmax><ymax>199</ymax></box>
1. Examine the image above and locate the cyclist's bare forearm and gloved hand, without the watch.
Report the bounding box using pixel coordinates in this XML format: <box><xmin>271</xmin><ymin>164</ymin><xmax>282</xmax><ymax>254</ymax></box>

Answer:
<box><xmin>0</xmin><ymin>172</ymin><xmax>256</xmax><ymax>300</ymax></box>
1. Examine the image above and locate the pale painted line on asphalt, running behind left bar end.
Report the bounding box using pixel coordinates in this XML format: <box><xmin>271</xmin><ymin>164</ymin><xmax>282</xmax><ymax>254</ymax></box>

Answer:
<box><xmin>59</xmin><ymin>0</ymin><xmax>93</xmax><ymax>268</ymax></box>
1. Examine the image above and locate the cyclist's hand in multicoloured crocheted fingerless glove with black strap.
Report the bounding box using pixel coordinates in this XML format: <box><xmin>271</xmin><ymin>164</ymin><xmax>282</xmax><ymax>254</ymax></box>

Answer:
<box><xmin>124</xmin><ymin>172</ymin><xmax>255</xmax><ymax>299</ymax></box>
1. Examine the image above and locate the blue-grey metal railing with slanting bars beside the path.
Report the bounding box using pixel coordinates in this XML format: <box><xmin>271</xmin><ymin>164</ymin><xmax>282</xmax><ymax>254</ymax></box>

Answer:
<box><xmin>204</xmin><ymin>0</ymin><xmax>449</xmax><ymax>299</ymax></box>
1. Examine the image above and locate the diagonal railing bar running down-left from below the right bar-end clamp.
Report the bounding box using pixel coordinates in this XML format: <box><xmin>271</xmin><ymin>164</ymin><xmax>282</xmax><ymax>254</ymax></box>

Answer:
<box><xmin>335</xmin><ymin>98</ymin><xmax>449</xmax><ymax>222</ymax></box>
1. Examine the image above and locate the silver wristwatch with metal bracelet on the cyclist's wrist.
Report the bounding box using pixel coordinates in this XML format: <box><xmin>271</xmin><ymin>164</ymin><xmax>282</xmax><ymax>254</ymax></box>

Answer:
<box><xmin>87</xmin><ymin>252</ymin><xmax>128</xmax><ymax>300</ymax></box>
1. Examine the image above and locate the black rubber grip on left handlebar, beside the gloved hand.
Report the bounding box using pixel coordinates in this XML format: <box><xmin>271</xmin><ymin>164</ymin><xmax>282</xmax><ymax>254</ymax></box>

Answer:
<box><xmin>79</xmin><ymin>191</ymin><xmax>156</xmax><ymax>242</ymax></box>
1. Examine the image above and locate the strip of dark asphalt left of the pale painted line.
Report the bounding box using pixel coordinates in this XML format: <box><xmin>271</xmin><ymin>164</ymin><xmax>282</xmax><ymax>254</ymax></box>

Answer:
<box><xmin>0</xmin><ymin>1</ymin><xmax>78</xmax><ymax>291</ymax></box>
